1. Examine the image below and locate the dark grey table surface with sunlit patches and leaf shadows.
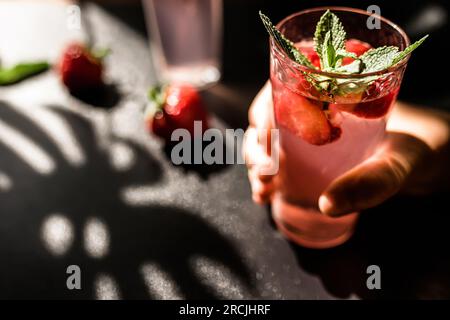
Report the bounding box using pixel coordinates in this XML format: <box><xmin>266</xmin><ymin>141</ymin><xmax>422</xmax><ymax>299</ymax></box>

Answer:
<box><xmin>0</xmin><ymin>1</ymin><xmax>450</xmax><ymax>299</ymax></box>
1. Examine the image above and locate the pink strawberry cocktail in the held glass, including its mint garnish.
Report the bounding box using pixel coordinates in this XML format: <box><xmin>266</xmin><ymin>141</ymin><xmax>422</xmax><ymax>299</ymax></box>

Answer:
<box><xmin>261</xmin><ymin>7</ymin><xmax>424</xmax><ymax>248</ymax></box>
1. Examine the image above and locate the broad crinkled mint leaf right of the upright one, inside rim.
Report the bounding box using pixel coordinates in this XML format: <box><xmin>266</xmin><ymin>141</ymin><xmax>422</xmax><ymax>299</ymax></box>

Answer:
<box><xmin>359</xmin><ymin>46</ymin><xmax>398</xmax><ymax>73</ymax></box>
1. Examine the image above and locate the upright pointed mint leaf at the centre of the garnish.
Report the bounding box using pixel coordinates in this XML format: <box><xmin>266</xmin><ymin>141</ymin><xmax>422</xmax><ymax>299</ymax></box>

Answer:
<box><xmin>314</xmin><ymin>10</ymin><xmax>346</xmax><ymax>66</ymax></box>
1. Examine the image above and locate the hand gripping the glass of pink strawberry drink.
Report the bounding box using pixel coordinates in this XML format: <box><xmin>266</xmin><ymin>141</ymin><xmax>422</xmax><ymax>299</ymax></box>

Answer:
<box><xmin>243</xmin><ymin>82</ymin><xmax>450</xmax><ymax>217</ymax></box>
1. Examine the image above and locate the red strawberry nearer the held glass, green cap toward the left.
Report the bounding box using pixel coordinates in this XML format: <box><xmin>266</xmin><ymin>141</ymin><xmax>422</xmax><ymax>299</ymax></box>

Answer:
<box><xmin>145</xmin><ymin>84</ymin><xmax>208</xmax><ymax>141</ymax></box>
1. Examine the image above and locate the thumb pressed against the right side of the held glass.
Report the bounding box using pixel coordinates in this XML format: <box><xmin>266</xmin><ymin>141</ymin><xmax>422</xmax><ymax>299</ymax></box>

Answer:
<box><xmin>319</xmin><ymin>132</ymin><xmax>429</xmax><ymax>216</ymax></box>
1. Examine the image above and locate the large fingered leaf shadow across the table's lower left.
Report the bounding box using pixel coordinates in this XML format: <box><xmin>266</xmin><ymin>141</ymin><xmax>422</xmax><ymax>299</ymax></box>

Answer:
<box><xmin>0</xmin><ymin>102</ymin><xmax>252</xmax><ymax>299</ymax></box>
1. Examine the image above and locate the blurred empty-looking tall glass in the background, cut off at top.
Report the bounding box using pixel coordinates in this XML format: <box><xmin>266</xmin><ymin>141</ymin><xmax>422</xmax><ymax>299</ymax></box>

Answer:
<box><xmin>143</xmin><ymin>0</ymin><xmax>222</xmax><ymax>87</ymax></box>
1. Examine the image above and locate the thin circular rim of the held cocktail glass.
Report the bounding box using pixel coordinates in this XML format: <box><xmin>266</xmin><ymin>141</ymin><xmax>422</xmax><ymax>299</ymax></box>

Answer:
<box><xmin>270</xmin><ymin>6</ymin><xmax>411</xmax><ymax>79</ymax></box>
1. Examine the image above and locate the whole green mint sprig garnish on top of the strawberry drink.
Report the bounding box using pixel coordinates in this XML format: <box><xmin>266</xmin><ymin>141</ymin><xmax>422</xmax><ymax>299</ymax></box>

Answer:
<box><xmin>259</xmin><ymin>10</ymin><xmax>428</xmax><ymax>96</ymax></box>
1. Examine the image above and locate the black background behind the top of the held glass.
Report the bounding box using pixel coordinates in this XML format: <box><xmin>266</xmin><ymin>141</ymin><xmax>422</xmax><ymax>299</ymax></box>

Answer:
<box><xmin>99</xmin><ymin>0</ymin><xmax>450</xmax><ymax>118</ymax></box>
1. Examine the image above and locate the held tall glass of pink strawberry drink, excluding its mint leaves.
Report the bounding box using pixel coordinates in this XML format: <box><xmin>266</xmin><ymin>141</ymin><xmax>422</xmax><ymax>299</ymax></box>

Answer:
<box><xmin>270</xmin><ymin>7</ymin><xmax>409</xmax><ymax>248</ymax></box>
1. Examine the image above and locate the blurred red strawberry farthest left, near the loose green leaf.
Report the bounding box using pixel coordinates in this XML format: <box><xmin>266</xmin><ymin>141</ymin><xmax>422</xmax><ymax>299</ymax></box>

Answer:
<box><xmin>59</xmin><ymin>43</ymin><xmax>103</xmax><ymax>93</ymax></box>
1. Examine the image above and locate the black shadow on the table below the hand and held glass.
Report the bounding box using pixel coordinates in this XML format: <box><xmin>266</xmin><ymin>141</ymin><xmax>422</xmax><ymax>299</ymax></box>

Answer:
<box><xmin>286</xmin><ymin>194</ymin><xmax>450</xmax><ymax>299</ymax></box>
